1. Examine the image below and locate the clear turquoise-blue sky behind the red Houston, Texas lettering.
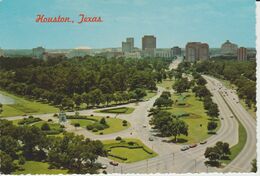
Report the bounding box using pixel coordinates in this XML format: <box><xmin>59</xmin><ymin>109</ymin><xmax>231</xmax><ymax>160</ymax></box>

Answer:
<box><xmin>0</xmin><ymin>0</ymin><xmax>256</xmax><ymax>49</ymax></box>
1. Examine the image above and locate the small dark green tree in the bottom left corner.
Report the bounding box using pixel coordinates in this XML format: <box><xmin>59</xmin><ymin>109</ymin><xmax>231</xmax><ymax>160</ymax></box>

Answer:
<box><xmin>0</xmin><ymin>151</ymin><xmax>15</xmax><ymax>174</ymax></box>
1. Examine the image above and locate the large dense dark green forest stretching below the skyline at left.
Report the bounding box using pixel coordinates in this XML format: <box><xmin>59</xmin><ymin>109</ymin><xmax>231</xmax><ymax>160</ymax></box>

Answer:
<box><xmin>0</xmin><ymin>56</ymin><xmax>174</xmax><ymax>107</ymax></box>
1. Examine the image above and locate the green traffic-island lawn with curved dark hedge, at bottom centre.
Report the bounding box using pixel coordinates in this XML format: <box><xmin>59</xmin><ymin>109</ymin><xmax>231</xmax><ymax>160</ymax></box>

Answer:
<box><xmin>102</xmin><ymin>138</ymin><xmax>157</xmax><ymax>163</ymax></box>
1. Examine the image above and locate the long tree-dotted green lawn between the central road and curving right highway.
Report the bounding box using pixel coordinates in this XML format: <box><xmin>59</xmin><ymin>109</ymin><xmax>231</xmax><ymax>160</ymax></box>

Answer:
<box><xmin>168</xmin><ymin>92</ymin><xmax>221</xmax><ymax>144</ymax></box>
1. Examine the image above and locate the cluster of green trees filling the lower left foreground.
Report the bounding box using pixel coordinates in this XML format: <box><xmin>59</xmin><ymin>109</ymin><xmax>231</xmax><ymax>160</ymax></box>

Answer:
<box><xmin>0</xmin><ymin>120</ymin><xmax>106</xmax><ymax>174</ymax></box>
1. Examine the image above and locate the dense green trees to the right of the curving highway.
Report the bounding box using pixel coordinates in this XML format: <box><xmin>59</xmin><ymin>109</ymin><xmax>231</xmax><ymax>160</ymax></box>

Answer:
<box><xmin>194</xmin><ymin>59</ymin><xmax>256</xmax><ymax>108</ymax></box>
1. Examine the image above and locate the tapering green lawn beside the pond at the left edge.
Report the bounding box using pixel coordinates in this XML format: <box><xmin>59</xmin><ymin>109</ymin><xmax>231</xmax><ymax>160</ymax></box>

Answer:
<box><xmin>0</xmin><ymin>90</ymin><xmax>59</xmax><ymax>117</ymax></box>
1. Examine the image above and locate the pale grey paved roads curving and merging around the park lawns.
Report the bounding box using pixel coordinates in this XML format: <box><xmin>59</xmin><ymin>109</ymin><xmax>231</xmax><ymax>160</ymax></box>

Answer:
<box><xmin>2</xmin><ymin>59</ymin><xmax>256</xmax><ymax>173</ymax></box>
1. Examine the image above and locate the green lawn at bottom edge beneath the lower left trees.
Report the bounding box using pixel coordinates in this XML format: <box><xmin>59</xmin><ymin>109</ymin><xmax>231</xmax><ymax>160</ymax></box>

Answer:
<box><xmin>12</xmin><ymin>161</ymin><xmax>68</xmax><ymax>174</ymax></box>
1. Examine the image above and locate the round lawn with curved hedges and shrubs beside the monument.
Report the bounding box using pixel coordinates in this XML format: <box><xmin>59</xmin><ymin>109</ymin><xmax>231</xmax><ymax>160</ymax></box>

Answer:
<box><xmin>69</xmin><ymin>116</ymin><xmax>131</xmax><ymax>134</ymax></box>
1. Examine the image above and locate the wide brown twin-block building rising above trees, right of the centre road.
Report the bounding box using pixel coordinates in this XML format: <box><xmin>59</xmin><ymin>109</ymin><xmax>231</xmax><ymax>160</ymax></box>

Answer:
<box><xmin>185</xmin><ymin>42</ymin><xmax>209</xmax><ymax>62</ymax></box>
